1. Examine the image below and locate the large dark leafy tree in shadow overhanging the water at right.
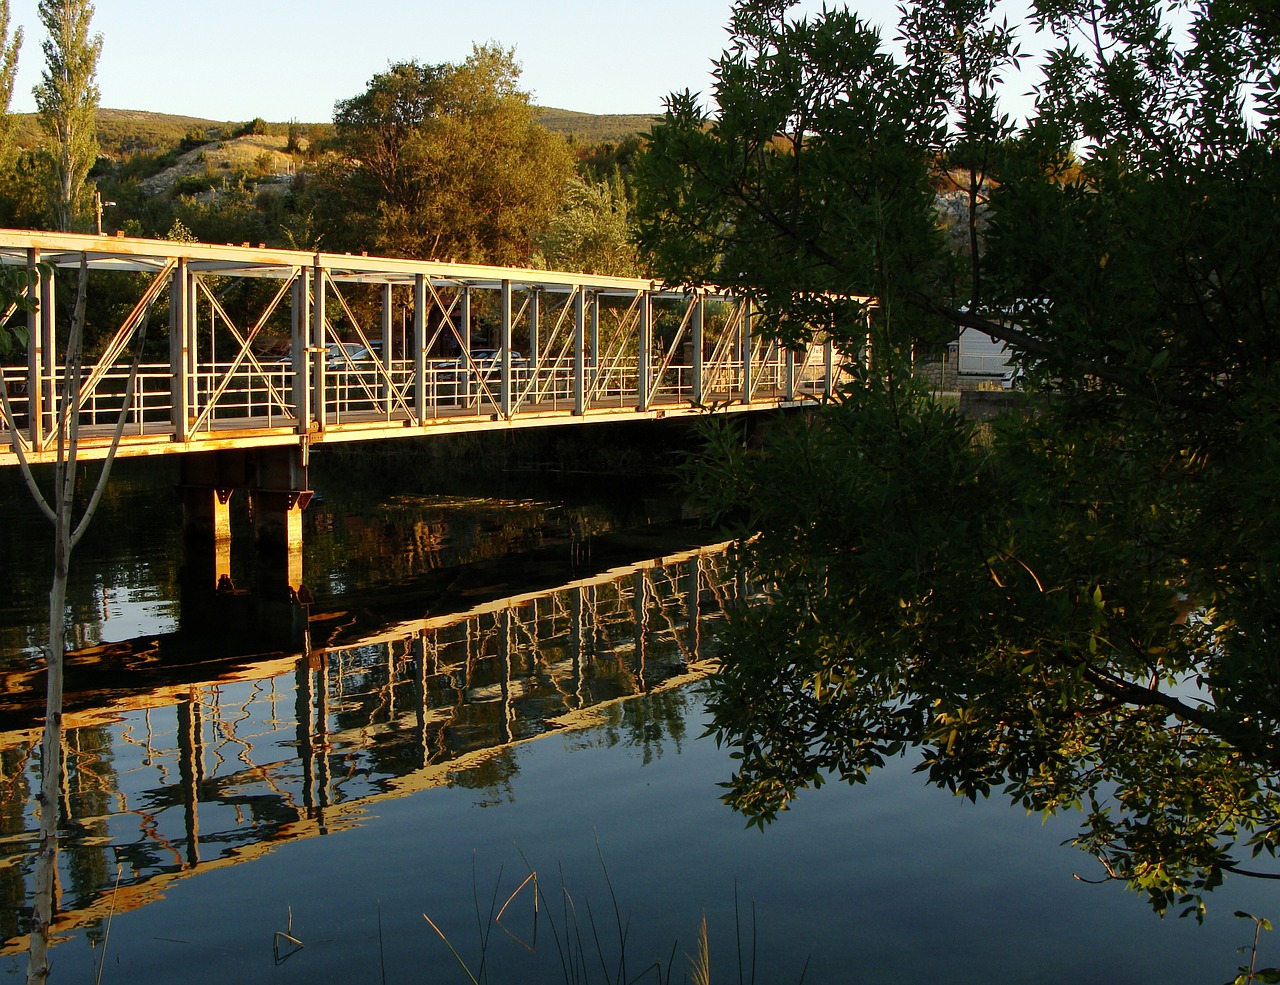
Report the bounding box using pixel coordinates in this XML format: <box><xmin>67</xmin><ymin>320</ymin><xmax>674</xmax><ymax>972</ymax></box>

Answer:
<box><xmin>637</xmin><ymin>0</ymin><xmax>1280</xmax><ymax>913</ymax></box>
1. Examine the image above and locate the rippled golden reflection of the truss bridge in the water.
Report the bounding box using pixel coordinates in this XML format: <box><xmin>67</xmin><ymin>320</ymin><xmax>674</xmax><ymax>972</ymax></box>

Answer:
<box><xmin>0</xmin><ymin>545</ymin><xmax>744</xmax><ymax>953</ymax></box>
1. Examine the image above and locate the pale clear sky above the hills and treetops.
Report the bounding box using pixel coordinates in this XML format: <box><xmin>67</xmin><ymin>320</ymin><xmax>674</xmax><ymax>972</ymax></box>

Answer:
<box><xmin>0</xmin><ymin>0</ymin><xmax>896</xmax><ymax>123</ymax></box>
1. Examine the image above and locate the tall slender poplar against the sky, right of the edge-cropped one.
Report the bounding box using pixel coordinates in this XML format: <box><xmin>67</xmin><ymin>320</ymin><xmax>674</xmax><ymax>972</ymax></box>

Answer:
<box><xmin>35</xmin><ymin>0</ymin><xmax>102</xmax><ymax>232</ymax></box>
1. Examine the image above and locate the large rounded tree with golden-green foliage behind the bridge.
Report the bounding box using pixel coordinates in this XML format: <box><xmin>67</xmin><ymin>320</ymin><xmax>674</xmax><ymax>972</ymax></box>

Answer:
<box><xmin>311</xmin><ymin>46</ymin><xmax>573</xmax><ymax>264</ymax></box>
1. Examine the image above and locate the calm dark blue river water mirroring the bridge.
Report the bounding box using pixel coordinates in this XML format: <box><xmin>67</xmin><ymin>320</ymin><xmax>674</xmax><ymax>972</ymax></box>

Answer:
<box><xmin>0</xmin><ymin>450</ymin><xmax>1280</xmax><ymax>985</ymax></box>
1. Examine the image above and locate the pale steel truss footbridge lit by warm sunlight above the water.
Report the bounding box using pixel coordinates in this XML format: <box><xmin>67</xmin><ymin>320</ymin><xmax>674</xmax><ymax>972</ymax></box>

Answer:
<box><xmin>0</xmin><ymin>230</ymin><xmax>860</xmax><ymax>466</ymax></box>
